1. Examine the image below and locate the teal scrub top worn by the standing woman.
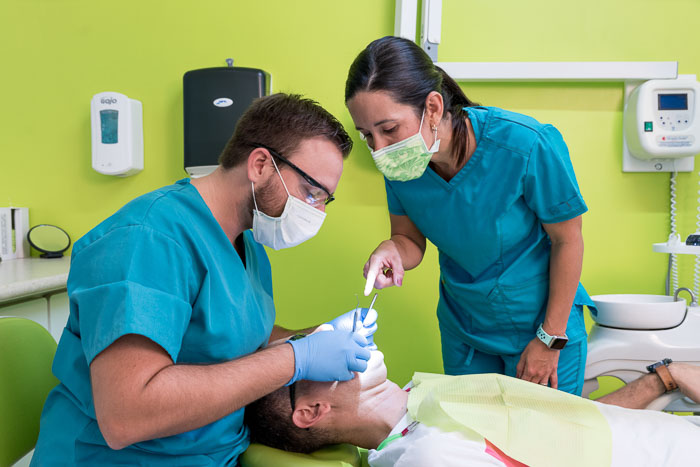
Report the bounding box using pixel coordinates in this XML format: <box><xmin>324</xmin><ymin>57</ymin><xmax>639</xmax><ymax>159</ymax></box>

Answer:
<box><xmin>385</xmin><ymin>107</ymin><xmax>592</xmax><ymax>355</ymax></box>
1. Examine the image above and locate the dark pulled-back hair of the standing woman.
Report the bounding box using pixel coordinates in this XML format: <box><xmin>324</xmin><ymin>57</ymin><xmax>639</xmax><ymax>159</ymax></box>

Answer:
<box><xmin>345</xmin><ymin>36</ymin><xmax>479</xmax><ymax>168</ymax></box>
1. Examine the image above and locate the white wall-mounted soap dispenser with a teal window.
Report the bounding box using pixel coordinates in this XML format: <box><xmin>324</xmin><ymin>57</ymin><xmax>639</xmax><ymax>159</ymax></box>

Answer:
<box><xmin>90</xmin><ymin>92</ymin><xmax>143</xmax><ymax>177</ymax></box>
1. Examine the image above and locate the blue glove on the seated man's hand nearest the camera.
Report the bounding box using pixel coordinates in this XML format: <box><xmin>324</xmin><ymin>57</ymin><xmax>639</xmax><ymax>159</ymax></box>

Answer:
<box><xmin>286</xmin><ymin>330</ymin><xmax>370</xmax><ymax>386</ymax></box>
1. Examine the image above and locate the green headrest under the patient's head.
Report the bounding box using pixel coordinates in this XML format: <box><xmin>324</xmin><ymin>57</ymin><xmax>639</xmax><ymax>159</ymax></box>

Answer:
<box><xmin>240</xmin><ymin>443</ymin><xmax>368</xmax><ymax>467</ymax></box>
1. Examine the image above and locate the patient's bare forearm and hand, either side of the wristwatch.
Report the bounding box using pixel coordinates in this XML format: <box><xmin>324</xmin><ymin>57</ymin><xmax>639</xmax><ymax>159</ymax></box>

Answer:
<box><xmin>597</xmin><ymin>362</ymin><xmax>700</xmax><ymax>409</ymax></box>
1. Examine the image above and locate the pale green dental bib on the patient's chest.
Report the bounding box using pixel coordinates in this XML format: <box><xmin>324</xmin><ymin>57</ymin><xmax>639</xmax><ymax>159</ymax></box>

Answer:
<box><xmin>408</xmin><ymin>373</ymin><xmax>612</xmax><ymax>467</ymax></box>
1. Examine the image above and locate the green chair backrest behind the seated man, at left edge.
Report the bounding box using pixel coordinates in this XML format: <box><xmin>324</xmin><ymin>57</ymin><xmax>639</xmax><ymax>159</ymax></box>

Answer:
<box><xmin>0</xmin><ymin>318</ymin><xmax>58</xmax><ymax>467</ymax></box>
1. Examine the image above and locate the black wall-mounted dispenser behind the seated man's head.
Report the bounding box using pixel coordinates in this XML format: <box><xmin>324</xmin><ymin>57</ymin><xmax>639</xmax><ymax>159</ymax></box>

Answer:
<box><xmin>182</xmin><ymin>59</ymin><xmax>271</xmax><ymax>177</ymax></box>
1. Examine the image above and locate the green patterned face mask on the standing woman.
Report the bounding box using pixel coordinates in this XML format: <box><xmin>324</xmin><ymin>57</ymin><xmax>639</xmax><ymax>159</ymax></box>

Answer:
<box><xmin>370</xmin><ymin>110</ymin><xmax>440</xmax><ymax>182</ymax></box>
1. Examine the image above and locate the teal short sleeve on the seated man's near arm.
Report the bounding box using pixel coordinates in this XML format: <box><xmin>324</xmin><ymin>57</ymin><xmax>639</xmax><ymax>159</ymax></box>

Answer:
<box><xmin>69</xmin><ymin>226</ymin><xmax>196</xmax><ymax>365</ymax></box>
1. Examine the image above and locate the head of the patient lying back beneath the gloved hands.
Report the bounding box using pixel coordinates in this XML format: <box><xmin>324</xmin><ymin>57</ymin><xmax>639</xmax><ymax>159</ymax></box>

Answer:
<box><xmin>245</xmin><ymin>351</ymin><xmax>406</xmax><ymax>453</ymax></box>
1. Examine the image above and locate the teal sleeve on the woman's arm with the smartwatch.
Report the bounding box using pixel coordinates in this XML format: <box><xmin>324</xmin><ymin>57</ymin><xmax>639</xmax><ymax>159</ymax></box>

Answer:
<box><xmin>523</xmin><ymin>125</ymin><xmax>588</xmax><ymax>224</ymax></box>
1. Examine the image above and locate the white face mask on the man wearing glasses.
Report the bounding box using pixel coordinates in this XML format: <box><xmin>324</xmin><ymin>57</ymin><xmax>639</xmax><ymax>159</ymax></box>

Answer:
<box><xmin>250</xmin><ymin>159</ymin><xmax>326</xmax><ymax>250</ymax></box>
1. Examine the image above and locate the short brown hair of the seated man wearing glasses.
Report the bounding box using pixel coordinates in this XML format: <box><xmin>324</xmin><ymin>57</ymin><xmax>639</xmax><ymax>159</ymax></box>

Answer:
<box><xmin>219</xmin><ymin>93</ymin><xmax>352</xmax><ymax>169</ymax></box>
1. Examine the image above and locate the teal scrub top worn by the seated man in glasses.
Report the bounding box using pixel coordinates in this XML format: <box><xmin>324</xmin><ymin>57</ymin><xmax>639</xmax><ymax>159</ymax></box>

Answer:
<box><xmin>32</xmin><ymin>179</ymin><xmax>275</xmax><ymax>466</ymax></box>
